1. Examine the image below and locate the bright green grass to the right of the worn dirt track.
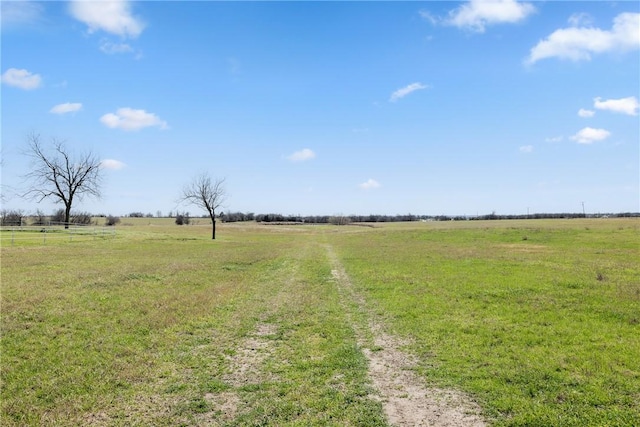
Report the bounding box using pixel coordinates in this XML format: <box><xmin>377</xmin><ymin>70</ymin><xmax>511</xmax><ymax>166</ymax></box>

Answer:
<box><xmin>337</xmin><ymin>219</ymin><xmax>640</xmax><ymax>426</ymax></box>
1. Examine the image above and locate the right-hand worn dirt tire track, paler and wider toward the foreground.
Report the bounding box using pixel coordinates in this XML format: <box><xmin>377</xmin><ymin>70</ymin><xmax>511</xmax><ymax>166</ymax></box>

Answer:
<box><xmin>326</xmin><ymin>245</ymin><xmax>486</xmax><ymax>427</ymax></box>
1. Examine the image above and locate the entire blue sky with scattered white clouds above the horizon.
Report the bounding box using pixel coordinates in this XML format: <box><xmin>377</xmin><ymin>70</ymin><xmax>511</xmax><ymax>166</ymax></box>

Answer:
<box><xmin>0</xmin><ymin>0</ymin><xmax>640</xmax><ymax>215</ymax></box>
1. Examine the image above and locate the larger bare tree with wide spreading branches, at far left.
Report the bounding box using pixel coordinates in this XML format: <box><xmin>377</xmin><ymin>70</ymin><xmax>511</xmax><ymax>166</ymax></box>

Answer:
<box><xmin>24</xmin><ymin>134</ymin><xmax>102</xmax><ymax>228</ymax></box>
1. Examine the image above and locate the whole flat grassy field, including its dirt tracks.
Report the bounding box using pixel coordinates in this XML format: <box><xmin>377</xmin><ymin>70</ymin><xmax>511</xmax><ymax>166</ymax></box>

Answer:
<box><xmin>0</xmin><ymin>218</ymin><xmax>640</xmax><ymax>427</ymax></box>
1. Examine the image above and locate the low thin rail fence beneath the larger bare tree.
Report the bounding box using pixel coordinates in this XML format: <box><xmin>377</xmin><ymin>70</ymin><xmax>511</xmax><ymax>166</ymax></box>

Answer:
<box><xmin>0</xmin><ymin>224</ymin><xmax>116</xmax><ymax>246</ymax></box>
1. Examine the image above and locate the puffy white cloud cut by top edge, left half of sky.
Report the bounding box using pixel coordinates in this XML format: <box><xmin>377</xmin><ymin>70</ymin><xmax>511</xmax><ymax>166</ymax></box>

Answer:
<box><xmin>69</xmin><ymin>0</ymin><xmax>144</xmax><ymax>38</ymax></box>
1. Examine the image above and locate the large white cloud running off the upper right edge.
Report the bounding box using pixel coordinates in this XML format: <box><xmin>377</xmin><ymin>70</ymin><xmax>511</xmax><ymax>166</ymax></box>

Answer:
<box><xmin>526</xmin><ymin>13</ymin><xmax>640</xmax><ymax>64</ymax></box>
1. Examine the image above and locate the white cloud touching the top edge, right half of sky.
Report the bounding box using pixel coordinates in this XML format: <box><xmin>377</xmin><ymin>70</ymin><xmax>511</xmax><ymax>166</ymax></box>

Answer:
<box><xmin>444</xmin><ymin>0</ymin><xmax>536</xmax><ymax>33</ymax></box>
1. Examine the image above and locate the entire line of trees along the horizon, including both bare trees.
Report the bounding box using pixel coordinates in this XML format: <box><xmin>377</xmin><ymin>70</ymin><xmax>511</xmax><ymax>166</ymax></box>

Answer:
<box><xmin>0</xmin><ymin>133</ymin><xmax>640</xmax><ymax>234</ymax></box>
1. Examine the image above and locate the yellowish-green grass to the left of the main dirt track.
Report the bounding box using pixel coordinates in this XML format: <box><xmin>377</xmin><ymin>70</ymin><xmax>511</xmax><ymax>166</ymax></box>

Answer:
<box><xmin>0</xmin><ymin>225</ymin><xmax>384</xmax><ymax>426</ymax></box>
